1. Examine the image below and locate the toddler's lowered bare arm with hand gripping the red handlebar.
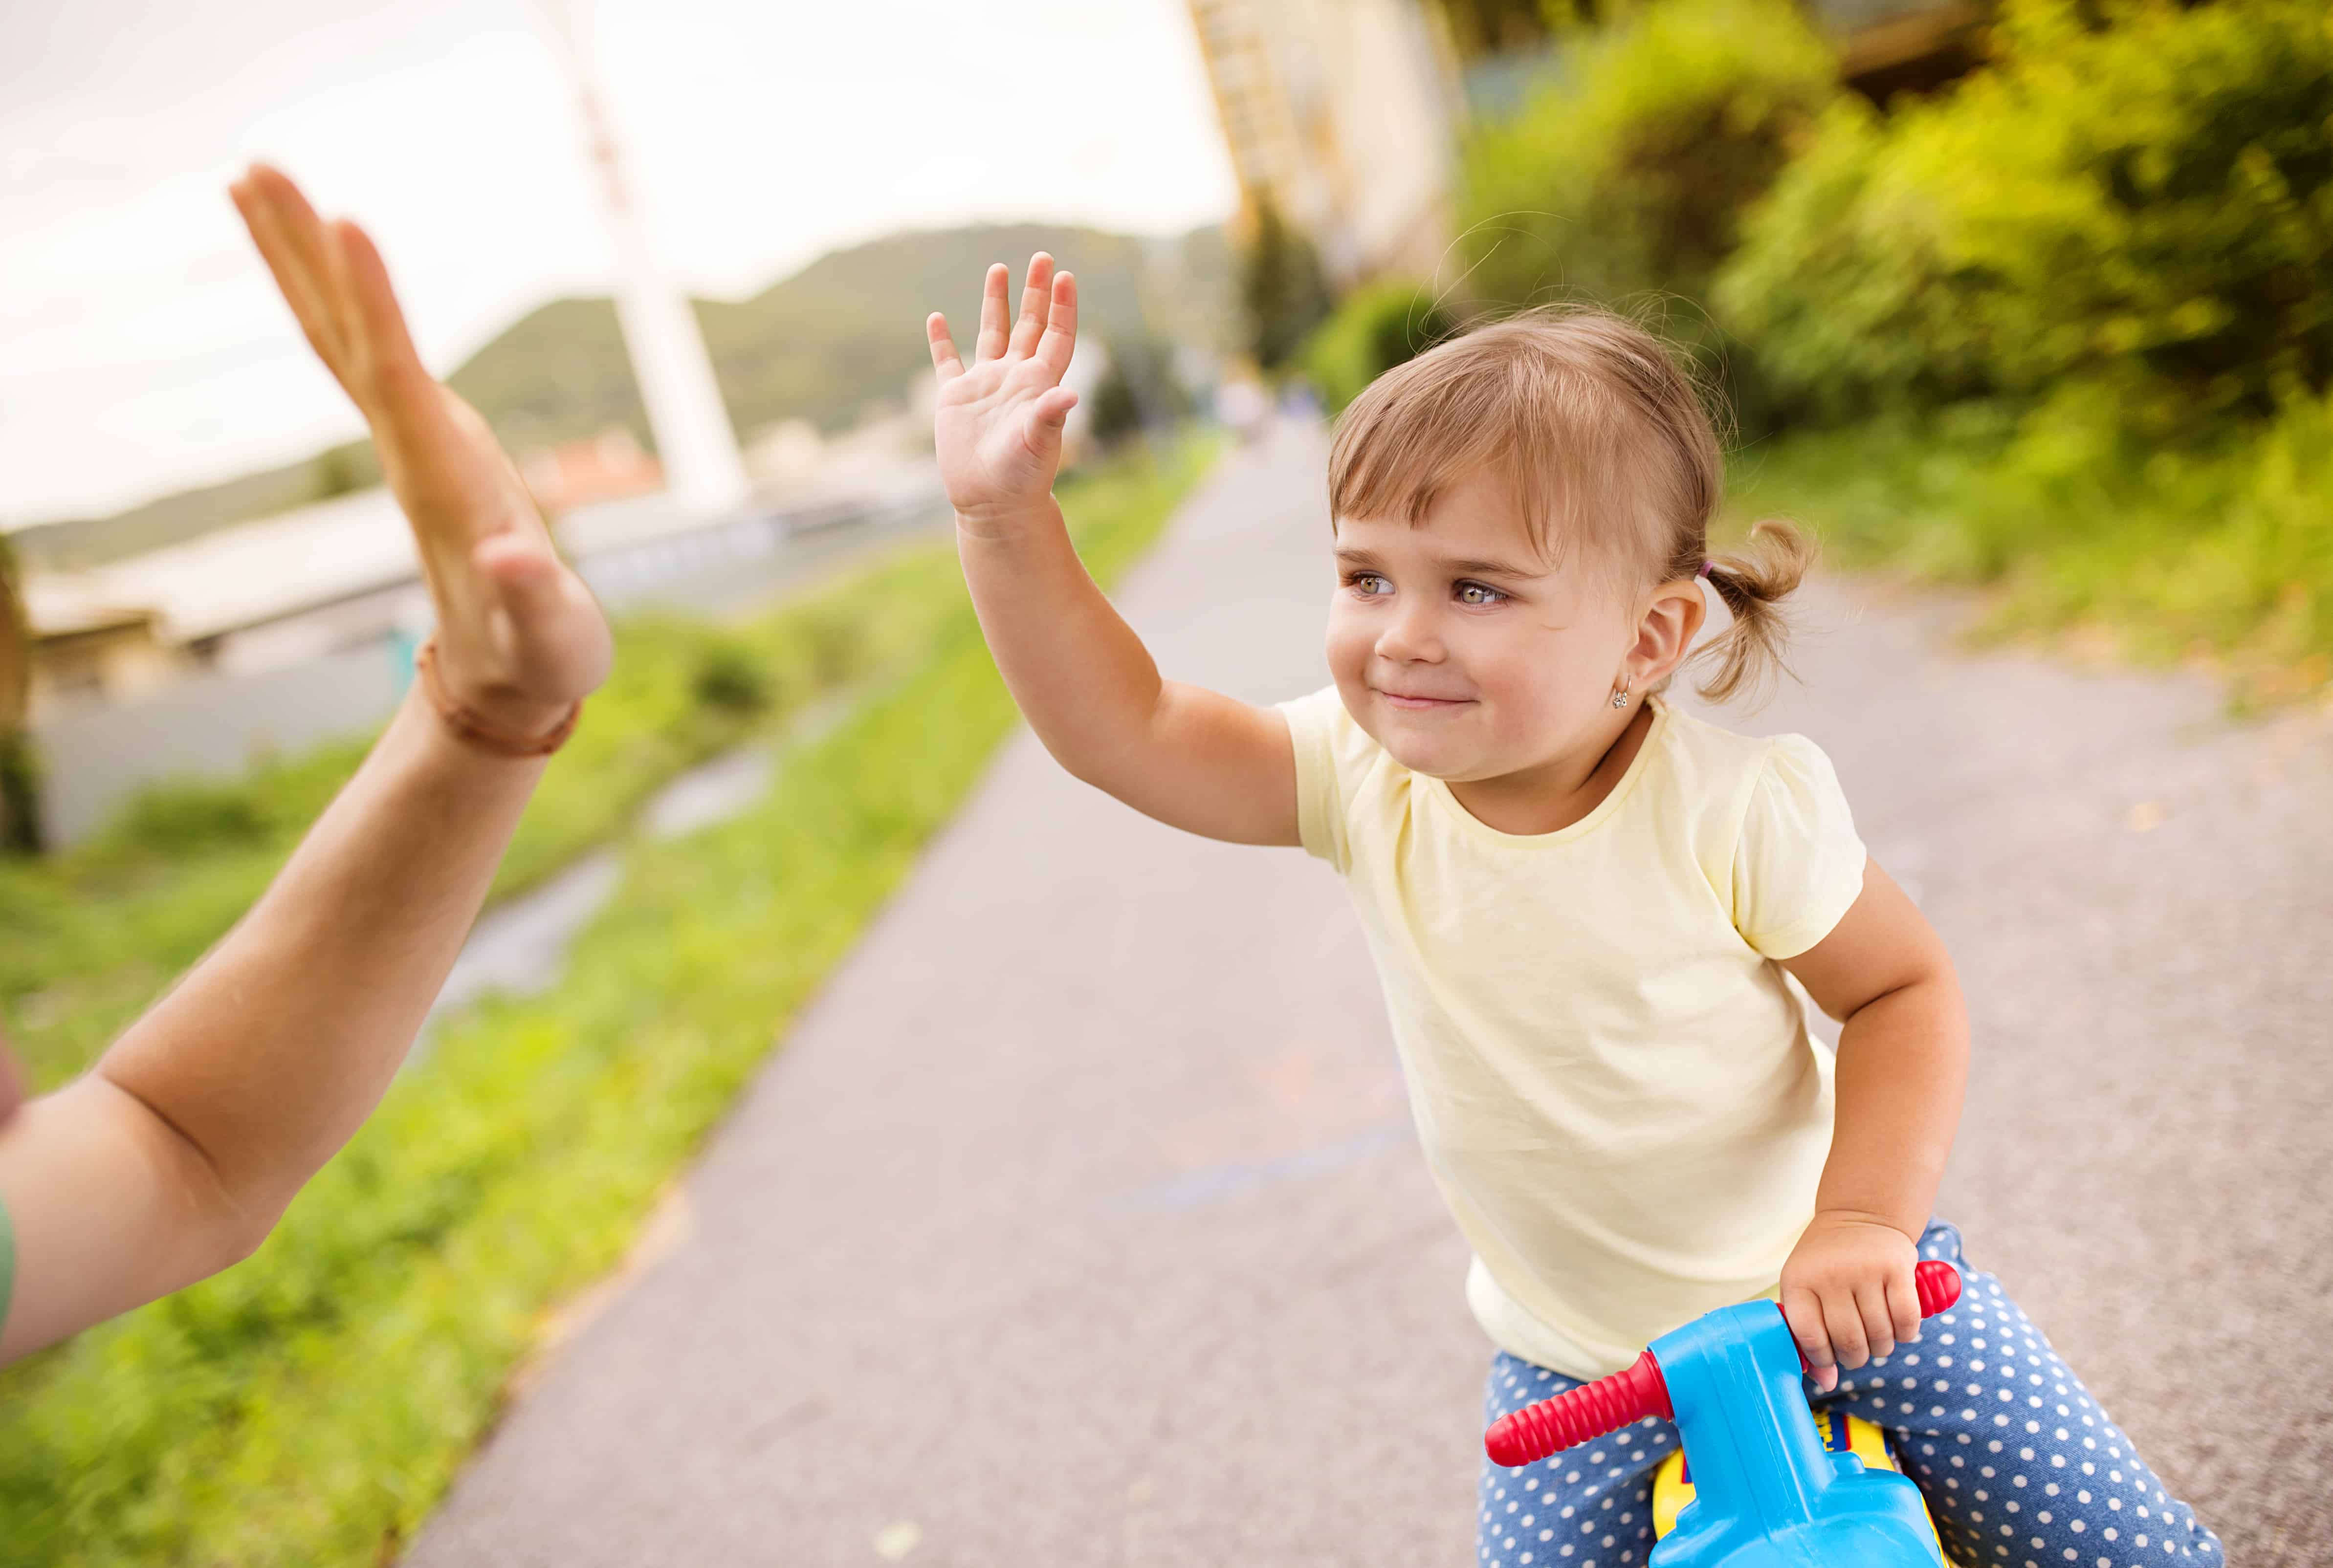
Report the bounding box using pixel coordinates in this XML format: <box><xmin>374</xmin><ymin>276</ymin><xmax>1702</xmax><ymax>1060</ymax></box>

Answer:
<box><xmin>1783</xmin><ymin>861</ymin><xmax>1969</xmax><ymax>1388</ymax></box>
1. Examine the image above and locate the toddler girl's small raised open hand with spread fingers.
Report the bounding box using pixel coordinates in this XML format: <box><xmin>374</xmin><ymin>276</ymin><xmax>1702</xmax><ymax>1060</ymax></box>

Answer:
<box><xmin>924</xmin><ymin>252</ymin><xmax>1078</xmax><ymax>527</ymax></box>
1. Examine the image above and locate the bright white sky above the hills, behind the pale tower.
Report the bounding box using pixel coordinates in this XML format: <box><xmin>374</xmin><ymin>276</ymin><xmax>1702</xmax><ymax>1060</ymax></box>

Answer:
<box><xmin>0</xmin><ymin>0</ymin><xmax>1236</xmax><ymax>527</ymax></box>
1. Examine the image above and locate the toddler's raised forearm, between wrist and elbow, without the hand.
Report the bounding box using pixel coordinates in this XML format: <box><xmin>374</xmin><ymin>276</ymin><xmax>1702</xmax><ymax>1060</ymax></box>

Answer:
<box><xmin>957</xmin><ymin>497</ymin><xmax>1166</xmax><ymax>793</ymax></box>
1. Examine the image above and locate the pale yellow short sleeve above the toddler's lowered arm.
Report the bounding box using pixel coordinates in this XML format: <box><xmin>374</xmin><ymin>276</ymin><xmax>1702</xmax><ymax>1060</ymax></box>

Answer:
<box><xmin>1734</xmin><ymin>735</ymin><xmax>1867</xmax><ymax>959</ymax></box>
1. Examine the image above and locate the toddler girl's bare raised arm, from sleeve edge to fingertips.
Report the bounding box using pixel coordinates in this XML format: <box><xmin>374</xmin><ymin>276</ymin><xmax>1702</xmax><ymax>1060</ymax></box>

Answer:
<box><xmin>926</xmin><ymin>254</ymin><xmax>1297</xmax><ymax>845</ymax></box>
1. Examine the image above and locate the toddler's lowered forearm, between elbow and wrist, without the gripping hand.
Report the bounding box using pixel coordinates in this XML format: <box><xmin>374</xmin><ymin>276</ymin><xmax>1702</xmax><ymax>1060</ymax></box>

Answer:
<box><xmin>1815</xmin><ymin>971</ymin><xmax>1969</xmax><ymax>1239</ymax></box>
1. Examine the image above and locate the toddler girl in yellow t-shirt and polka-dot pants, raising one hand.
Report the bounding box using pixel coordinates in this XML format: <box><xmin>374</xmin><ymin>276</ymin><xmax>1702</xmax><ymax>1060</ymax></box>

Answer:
<box><xmin>928</xmin><ymin>257</ymin><xmax>2219</xmax><ymax>1568</ymax></box>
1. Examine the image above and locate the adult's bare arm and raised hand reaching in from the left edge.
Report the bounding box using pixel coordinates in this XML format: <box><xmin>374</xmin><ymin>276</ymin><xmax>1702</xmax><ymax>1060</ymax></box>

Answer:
<box><xmin>0</xmin><ymin>166</ymin><xmax>611</xmax><ymax>1360</ymax></box>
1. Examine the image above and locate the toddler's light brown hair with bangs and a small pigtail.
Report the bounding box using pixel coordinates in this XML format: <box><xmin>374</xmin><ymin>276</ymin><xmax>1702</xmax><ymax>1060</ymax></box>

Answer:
<box><xmin>1327</xmin><ymin>308</ymin><xmax>1815</xmax><ymax>702</ymax></box>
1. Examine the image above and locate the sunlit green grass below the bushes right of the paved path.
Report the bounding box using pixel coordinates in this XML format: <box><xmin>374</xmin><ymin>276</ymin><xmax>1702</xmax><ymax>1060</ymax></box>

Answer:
<box><xmin>1731</xmin><ymin>399</ymin><xmax>2333</xmax><ymax>709</ymax></box>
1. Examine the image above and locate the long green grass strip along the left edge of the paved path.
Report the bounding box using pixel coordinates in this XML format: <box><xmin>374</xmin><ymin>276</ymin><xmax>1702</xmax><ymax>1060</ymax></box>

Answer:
<box><xmin>0</xmin><ymin>432</ymin><xmax>1209</xmax><ymax>1568</ymax></box>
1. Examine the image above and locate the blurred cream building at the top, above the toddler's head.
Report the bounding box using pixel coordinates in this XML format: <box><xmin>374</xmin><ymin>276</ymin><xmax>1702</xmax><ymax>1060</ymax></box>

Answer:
<box><xmin>1190</xmin><ymin>0</ymin><xmax>1463</xmax><ymax>289</ymax></box>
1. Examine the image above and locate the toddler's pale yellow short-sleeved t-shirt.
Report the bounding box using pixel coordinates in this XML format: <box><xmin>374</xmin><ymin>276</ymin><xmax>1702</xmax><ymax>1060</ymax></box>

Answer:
<box><xmin>1281</xmin><ymin>688</ymin><xmax>1864</xmax><ymax>1377</ymax></box>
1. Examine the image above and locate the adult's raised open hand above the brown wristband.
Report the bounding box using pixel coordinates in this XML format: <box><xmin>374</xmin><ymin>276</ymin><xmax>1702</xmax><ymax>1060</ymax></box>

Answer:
<box><xmin>229</xmin><ymin>163</ymin><xmax>614</xmax><ymax>738</ymax></box>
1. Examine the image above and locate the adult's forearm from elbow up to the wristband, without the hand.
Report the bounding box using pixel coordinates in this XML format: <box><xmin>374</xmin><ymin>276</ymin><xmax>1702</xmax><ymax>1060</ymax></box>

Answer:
<box><xmin>96</xmin><ymin>693</ymin><xmax>544</xmax><ymax>1239</ymax></box>
